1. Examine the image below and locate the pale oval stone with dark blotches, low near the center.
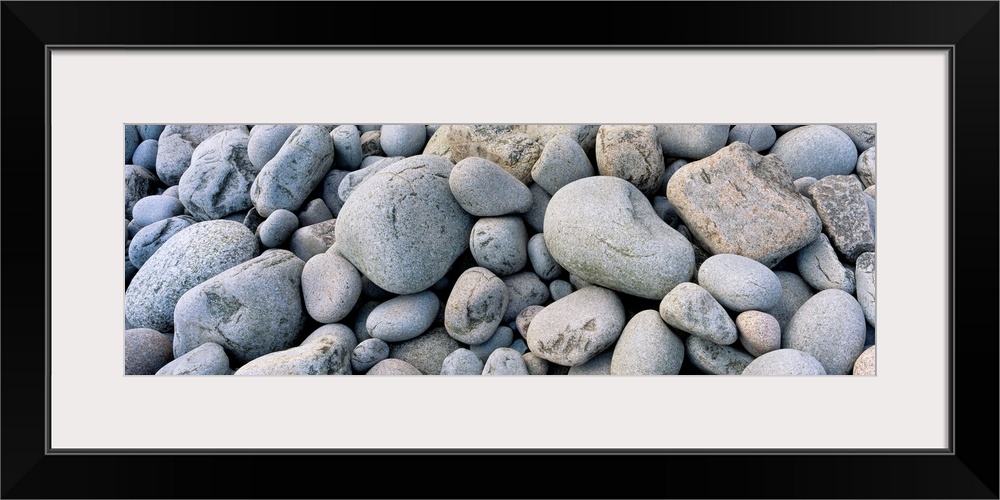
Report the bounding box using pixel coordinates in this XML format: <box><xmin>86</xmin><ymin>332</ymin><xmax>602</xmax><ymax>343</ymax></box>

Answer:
<box><xmin>525</xmin><ymin>286</ymin><xmax>625</xmax><ymax>366</ymax></box>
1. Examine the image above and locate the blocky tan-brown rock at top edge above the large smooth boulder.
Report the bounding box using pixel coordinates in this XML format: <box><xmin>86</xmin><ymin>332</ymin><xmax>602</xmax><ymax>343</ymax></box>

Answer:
<box><xmin>592</xmin><ymin>125</ymin><xmax>665</xmax><ymax>196</ymax></box>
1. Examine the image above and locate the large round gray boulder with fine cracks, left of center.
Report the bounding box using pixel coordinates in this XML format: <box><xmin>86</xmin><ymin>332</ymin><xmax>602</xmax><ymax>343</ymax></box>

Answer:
<box><xmin>336</xmin><ymin>155</ymin><xmax>473</xmax><ymax>294</ymax></box>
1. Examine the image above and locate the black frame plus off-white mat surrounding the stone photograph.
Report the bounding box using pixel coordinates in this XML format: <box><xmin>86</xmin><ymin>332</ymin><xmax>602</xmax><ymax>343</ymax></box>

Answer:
<box><xmin>2</xmin><ymin>2</ymin><xmax>1000</xmax><ymax>498</ymax></box>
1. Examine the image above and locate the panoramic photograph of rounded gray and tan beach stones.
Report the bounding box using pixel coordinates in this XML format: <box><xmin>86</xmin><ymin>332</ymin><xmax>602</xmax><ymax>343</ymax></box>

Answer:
<box><xmin>123</xmin><ymin>123</ymin><xmax>876</xmax><ymax>376</ymax></box>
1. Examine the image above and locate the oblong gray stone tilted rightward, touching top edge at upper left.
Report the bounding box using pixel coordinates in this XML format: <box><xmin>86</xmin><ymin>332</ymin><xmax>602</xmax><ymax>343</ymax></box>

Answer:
<box><xmin>250</xmin><ymin>125</ymin><xmax>334</xmax><ymax>217</ymax></box>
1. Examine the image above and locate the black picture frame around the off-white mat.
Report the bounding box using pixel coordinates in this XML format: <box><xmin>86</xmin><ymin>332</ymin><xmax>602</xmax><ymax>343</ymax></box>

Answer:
<box><xmin>0</xmin><ymin>1</ymin><xmax>1000</xmax><ymax>498</ymax></box>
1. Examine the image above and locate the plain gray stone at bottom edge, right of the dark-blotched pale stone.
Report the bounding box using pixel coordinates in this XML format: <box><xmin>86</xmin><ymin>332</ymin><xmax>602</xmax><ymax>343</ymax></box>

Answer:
<box><xmin>610</xmin><ymin>310</ymin><xmax>684</xmax><ymax>375</ymax></box>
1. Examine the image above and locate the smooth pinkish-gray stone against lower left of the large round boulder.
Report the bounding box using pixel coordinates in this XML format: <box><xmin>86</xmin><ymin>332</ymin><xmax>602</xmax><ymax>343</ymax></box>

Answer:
<box><xmin>302</xmin><ymin>252</ymin><xmax>361</xmax><ymax>323</ymax></box>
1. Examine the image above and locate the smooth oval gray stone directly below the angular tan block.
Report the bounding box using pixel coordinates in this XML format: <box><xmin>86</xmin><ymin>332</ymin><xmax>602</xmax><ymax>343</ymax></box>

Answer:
<box><xmin>698</xmin><ymin>254</ymin><xmax>781</xmax><ymax>312</ymax></box>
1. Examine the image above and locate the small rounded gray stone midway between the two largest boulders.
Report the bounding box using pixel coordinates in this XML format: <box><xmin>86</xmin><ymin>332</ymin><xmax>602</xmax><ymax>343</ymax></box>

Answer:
<box><xmin>469</xmin><ymin>216</ymin><xmax>528</xmax><ymax>276</ymax></box>
